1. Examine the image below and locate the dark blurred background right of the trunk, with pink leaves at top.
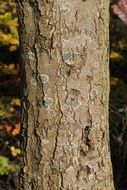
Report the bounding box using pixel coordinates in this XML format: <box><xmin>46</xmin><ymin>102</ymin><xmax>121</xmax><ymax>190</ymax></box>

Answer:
<box><xmin>109</xmin><ymin>0</ymin><xmax>127</xmax><ymax>190</ymax></box>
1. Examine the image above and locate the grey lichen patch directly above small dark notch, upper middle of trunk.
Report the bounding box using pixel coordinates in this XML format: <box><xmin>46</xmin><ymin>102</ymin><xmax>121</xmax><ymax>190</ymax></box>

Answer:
<box><xmin>62</xmin><ymin>52</ymin><xmax>74</xmax><ymax>65</ymax></box>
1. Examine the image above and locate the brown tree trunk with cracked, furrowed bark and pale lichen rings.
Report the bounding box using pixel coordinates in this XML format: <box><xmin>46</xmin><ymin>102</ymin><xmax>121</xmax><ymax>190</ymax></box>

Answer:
<box><xmin>17</xmin><ymin>0</ymin><xmax>114</xmax><ymax>190</ymax></box>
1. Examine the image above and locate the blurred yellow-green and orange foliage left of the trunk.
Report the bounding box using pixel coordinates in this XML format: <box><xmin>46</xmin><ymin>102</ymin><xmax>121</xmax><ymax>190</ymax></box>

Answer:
<box><xmin>0</xmin><ymin>0</ymin><xmax>21</xmax><ymax>190</ymax></box>
